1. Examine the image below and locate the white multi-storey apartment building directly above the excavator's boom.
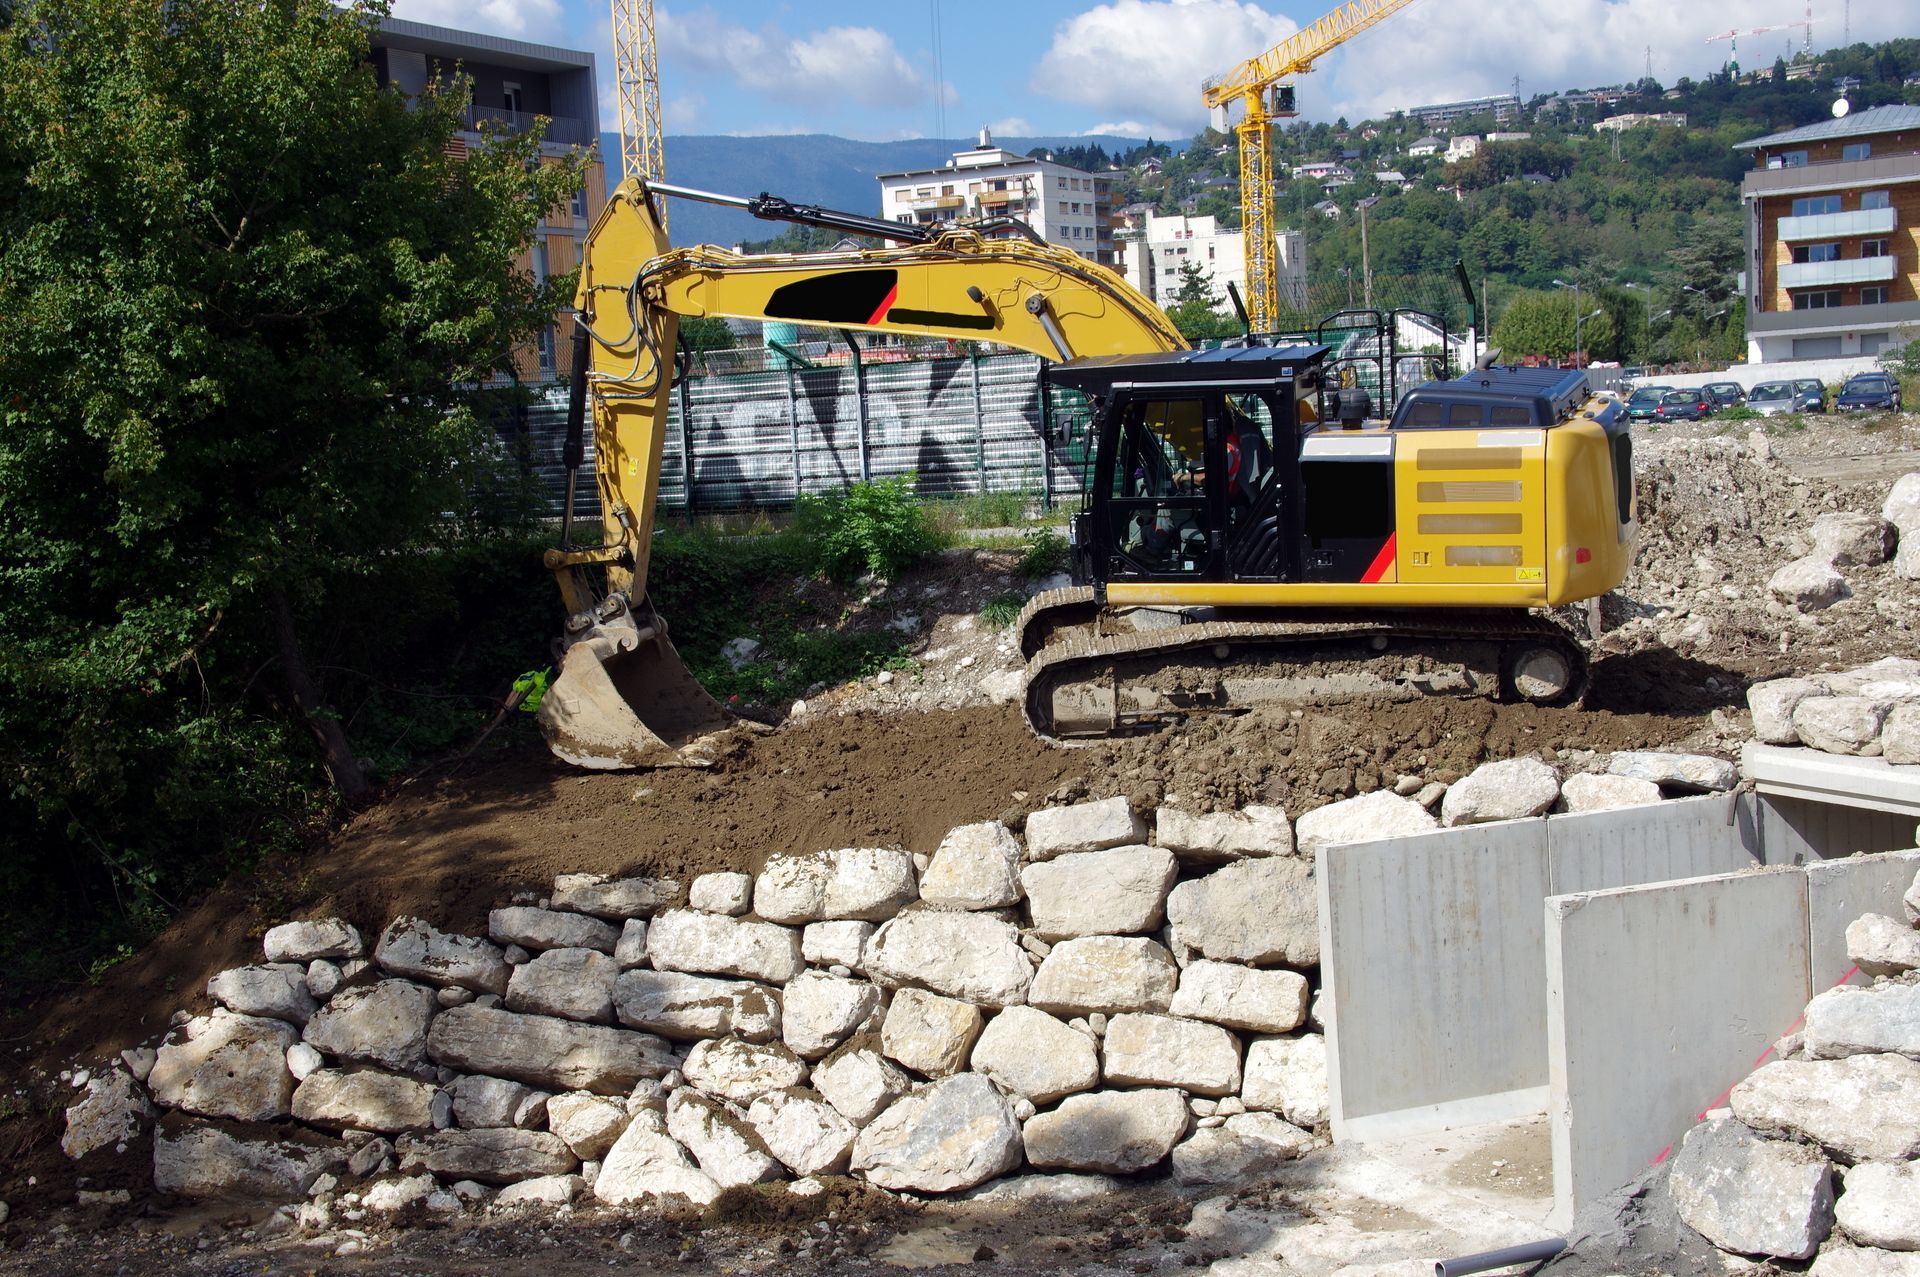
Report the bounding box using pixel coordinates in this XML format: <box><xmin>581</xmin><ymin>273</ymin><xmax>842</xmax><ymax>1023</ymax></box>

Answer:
<box><xmin>877</xmin><ymin>129</ymin><xmax>1117</xmax><ymax>267</ymax></box>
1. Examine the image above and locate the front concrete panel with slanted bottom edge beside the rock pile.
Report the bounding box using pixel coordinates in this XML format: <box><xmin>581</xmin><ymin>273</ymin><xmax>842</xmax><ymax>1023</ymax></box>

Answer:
<box><xmin>1544</xmin><ymin>870</ymin><xmax>1812</xmax><ymax>1227</ymax></box>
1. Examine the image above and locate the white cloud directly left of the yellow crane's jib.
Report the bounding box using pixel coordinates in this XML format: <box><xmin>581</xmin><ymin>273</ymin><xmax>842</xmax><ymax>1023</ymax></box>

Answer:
<box><xmin>1029</xmin><ymin>0</ymin><xmax>1298</xmax><ymax>136</ymax></box>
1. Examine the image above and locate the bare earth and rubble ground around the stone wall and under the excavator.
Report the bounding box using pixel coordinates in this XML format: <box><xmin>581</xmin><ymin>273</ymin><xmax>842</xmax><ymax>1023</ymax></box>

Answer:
<box><xmin>0</xmin><ymin>405</ymin><xmax>1920</xmax><ymax>1273</ymax></box>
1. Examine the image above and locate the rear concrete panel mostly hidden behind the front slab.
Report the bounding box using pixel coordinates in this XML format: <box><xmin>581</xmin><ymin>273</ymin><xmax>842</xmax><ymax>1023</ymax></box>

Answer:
<box><xmin>1548</xmin><ymin>793</ymin><xmax>1757</xmax><ymax>895</ymax></box>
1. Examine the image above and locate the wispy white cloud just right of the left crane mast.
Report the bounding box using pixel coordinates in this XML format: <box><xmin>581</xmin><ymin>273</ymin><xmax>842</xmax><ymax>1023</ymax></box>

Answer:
<box><xmin>657</xmin><ymin>10</ymin><xmax>936</xmax><ymax>108</ymax></box>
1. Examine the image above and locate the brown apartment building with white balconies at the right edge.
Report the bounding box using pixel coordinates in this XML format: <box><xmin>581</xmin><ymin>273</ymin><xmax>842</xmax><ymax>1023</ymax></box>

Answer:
<box><xmin>1736</xmin><ymin>106</ymin><xmax>1920</xmax><ymax>363</ymax></box>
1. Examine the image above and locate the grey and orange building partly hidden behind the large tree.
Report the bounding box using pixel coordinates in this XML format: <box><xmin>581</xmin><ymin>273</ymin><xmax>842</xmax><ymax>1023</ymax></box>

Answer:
<box><xmin>372</xmin><ymin>17</ymin><xmax>607</xmax><ymax>384</ymax></box>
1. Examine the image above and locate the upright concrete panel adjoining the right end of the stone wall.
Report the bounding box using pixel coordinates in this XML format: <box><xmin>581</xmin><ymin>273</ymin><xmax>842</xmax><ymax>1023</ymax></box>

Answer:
<box><xmin>1317</xmin><ymin>820</ymin><xmax>1548</xmax><ymax>1139</ymax></box>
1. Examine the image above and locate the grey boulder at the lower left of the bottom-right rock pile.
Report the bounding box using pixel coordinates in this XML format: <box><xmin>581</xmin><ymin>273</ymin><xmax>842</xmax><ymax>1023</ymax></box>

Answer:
<box><xmin>1667</xmin><ymin>1120</ymin><xmax>1834</xmax><ymax>1260</ymax></box>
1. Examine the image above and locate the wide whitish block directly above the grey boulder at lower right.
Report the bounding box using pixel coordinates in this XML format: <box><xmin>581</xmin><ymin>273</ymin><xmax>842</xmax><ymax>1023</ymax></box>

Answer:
<box><xmin>1730</xmin><ymin>1054</ymin><xmax>1920</xmax><ymax>1162</ymax></box>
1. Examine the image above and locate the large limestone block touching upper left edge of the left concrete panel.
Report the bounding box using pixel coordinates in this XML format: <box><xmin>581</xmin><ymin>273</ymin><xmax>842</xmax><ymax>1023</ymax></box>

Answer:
<box><xmin>1167</xmin><ymin>856</ymin><xmax>1320</xmax><ymax>966</ymax></box>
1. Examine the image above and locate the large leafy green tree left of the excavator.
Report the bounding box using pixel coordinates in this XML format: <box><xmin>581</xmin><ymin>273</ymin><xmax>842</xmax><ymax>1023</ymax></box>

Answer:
<box><xmin>0</xmin><ymin>0</ymin><xmax>586</xmax><ymax>940</ymax></box>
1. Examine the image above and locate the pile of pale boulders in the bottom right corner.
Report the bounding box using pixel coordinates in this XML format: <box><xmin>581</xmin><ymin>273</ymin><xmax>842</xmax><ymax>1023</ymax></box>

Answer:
<box><xmin>1667</xmin><ymin>860</ymin><xmax>1920</xmax><ymax>1277</ymax></box>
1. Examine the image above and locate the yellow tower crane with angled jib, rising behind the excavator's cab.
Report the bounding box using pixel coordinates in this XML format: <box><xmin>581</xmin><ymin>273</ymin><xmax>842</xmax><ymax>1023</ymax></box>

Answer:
<box><xmin>1202</xmin><ymin>0</ymin><xmax>1413</xmax><ymax>332</ymax></box>
